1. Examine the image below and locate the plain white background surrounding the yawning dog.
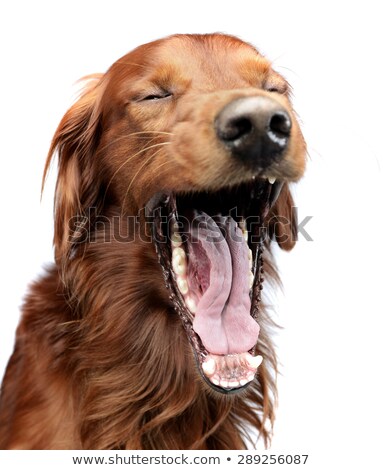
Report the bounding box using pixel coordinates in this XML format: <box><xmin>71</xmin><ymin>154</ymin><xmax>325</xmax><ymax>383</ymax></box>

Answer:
<box><xmin>0</xmin><ymin>0</ymin><xmax>383</xmax><ymax>470</ymax></box>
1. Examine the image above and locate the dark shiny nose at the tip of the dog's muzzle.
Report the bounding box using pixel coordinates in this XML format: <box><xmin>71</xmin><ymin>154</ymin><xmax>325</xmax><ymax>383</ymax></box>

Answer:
<box><xmin>215</xmin><ymin>96</ymin><xmax>291</xmax><ymax>168</ymax></box>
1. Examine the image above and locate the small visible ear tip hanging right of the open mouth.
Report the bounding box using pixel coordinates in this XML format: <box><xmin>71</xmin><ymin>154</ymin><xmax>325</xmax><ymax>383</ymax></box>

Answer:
<box><xmin>268</xmin><ymin>183</ymin><xmax>298</xmax><ymax>251</ymax></box>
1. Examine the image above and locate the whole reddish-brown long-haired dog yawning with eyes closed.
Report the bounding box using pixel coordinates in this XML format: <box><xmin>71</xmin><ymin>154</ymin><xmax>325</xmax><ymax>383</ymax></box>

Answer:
<box><xmin>0</xmin><ymin>34</ymin><xmax>306</xmax><ymax>449</ymax></box>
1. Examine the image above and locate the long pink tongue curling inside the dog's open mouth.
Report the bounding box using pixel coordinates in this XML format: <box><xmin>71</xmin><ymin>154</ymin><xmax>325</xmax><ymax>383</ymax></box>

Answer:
<box><xmin>189</xmin><ymin>213</ymin><xmax>259</xmax><ymax>354</ymax></box>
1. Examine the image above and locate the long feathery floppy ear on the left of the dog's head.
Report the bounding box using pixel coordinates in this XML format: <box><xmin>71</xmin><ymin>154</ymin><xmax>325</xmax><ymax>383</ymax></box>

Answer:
<box><xmin>43</xmin><ymin>75</ymin><xmax>102</xmax><ymax>263</ymax></box>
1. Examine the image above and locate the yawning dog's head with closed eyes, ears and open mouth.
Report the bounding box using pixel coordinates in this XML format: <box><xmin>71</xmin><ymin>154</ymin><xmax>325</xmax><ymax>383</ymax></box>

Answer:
<box><xmin>47</xmin><ymin>34</ymin><xmax>306</xmax><ymax>392</ymax></box>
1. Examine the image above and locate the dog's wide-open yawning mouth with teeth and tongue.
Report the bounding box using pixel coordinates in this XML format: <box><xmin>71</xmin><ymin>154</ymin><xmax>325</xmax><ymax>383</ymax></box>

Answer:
<box><xmin>146</xmin><ymin>178</ymin><xmax>283</xmax><ymax>393</ymax></box>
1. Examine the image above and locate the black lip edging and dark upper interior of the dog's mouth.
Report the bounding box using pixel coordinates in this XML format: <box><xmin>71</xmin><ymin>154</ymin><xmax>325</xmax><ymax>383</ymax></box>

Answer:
<box><xmin>145</xmin><ymin>179</ymin><xmax>283</xmax><ymax>395</ymax></box>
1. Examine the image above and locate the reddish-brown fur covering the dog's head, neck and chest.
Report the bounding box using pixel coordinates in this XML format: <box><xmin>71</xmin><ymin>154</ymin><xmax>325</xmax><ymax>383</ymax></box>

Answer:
<box><xmin>0</xmin><ymin>35</ymin><xmax>305</xmax><ymax>449</ymax></box>
